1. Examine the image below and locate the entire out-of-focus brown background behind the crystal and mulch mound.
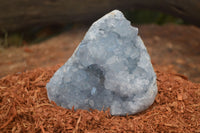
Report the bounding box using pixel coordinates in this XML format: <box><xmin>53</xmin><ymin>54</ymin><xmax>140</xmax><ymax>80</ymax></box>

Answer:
<box><xmin>0</xmin><ymin>0</ymin><xmax>200</xmax><ymax>83</ymax></box>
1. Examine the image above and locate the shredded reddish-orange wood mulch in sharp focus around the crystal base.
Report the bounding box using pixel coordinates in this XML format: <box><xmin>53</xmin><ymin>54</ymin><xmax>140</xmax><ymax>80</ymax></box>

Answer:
<box><xmin>0</xmin><ymin>66</ymin><xmax>200</xmax><ymax>133</ymax></box>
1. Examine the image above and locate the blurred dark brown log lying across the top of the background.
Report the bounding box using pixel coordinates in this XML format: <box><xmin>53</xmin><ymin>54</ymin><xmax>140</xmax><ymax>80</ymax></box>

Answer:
<box><xmin>0</xmin><ymin>0</ymin><xmax>200</xmax><ymax>31</ymax></box>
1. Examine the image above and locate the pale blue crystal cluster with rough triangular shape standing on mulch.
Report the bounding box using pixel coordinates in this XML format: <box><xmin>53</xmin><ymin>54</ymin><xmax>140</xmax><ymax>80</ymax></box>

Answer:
<box><xmin>46</xmin><ymin>10</ymin><xmax>157</xmax><ymax>115</ymax></box>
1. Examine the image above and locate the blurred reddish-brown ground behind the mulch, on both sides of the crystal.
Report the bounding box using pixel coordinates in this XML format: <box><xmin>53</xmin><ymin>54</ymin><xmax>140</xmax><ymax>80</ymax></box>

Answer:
<box><xmin>0</xmin><ymin>24</ymin><xmax>200</xmax><ymax>82</ymax></box>
